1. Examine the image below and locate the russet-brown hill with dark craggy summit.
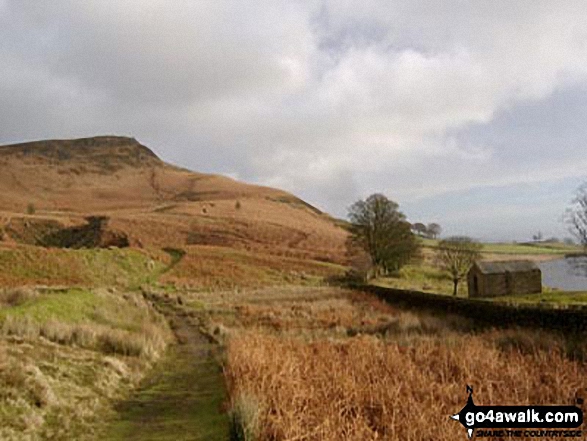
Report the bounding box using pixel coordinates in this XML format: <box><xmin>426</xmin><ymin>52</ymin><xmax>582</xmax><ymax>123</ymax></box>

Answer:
<box><xmin>0</xmin><ymin>136</ymin><xmax>346</xmax><ymax>261</ymax></box>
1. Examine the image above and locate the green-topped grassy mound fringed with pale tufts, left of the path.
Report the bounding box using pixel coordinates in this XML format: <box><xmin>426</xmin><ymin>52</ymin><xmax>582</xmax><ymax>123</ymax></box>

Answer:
<box><xmin>0</xmin><ymin>289</ymin><xmax>169</xmax><ymax>359</ymax></box>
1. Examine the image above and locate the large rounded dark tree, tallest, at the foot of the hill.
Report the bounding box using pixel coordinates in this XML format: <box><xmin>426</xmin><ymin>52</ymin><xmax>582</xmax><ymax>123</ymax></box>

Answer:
<box><xmin>348</xmin><ymin>194</ymin><xmax>418</xmax><ymax>276</ymax></box>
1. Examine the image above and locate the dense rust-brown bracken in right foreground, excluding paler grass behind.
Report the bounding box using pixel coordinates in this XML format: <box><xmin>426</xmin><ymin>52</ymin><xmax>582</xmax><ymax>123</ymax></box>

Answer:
<box><xmin>225</xmin><ymin>330</ymin><xmax>587</xmax><ymax>441</ymax></box>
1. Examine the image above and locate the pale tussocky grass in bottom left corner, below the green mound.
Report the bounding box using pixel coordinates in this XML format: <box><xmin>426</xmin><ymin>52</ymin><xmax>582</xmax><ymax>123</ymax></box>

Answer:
<box><xmin>0</xmin><ymin>338</ymin><xmax>144</xmax><ymax>441</ymax></box>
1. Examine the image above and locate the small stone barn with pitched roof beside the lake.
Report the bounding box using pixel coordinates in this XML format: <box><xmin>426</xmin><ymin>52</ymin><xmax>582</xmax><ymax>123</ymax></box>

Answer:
<box><xmin>467</xmin><ymin>260</ymin><xmax>542</xmax><ymax>297</ymax></box>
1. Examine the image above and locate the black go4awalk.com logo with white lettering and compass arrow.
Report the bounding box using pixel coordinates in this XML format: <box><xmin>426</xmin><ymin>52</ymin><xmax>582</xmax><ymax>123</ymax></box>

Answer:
<box><xmin>451</xmin><ymin>386</ymin><xmax>583</xmax><ymax>438</ymax></box>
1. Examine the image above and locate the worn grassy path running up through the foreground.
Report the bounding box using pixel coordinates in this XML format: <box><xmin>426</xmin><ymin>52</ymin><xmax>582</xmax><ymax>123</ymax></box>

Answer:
<box><xmin>103</xmin><ymin>304</ymin><xmax>229</xmax><ymax>441</ymax></box>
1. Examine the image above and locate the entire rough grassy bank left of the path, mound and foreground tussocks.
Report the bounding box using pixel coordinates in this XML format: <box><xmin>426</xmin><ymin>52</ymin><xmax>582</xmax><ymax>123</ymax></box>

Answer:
<box><xmin>0</xmin><ymin>288</ymin><xmax>171</xmax><ymax>440</ymax></box>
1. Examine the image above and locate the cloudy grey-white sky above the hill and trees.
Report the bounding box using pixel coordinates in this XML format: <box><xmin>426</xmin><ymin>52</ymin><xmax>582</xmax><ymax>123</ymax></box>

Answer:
<box><xmin>0</xmin><ymin>0</ymin><xmax>587</xmax><ymax>241</ymax></box>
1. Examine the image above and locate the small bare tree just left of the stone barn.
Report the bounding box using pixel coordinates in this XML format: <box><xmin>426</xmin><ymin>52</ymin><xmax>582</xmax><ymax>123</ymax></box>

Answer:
<box><xmin>438</xmin><ymin>236</ymin><xmax>481</xmax><ymax>296</ymax></box>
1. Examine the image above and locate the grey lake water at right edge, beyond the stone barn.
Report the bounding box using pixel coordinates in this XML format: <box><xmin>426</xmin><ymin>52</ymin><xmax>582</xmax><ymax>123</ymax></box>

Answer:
<box><xmin>538</xmin><ymin>256</ymin><xmax>587</xmax><ymax>291</ymax></box>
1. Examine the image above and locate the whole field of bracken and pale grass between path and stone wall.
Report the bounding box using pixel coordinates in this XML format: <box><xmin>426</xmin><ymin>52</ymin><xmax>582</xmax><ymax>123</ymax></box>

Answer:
<box><xmin>189</xmin><ymin>287</ymin><xmax>587</xmax><ymax>440</ymax></box>
